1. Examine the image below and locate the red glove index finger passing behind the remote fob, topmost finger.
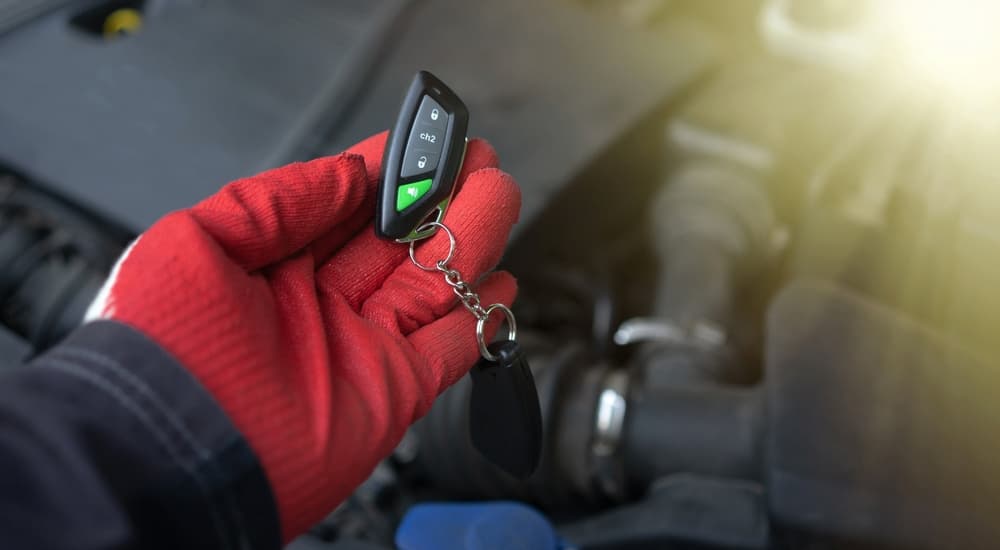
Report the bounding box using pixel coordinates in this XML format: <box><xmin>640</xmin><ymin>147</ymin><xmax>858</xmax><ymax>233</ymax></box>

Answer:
<box><xmin>317</xmin><ymin>139</ymin><xmax>497</xmax><ymax>311</ymax></box>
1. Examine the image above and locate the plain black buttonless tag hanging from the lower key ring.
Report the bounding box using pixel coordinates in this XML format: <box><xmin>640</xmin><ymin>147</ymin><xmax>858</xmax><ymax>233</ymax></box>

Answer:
<box><xmin>469</xmin><ymin>340</ymin><xmax>542</xmax><ymax>478</ymax></box>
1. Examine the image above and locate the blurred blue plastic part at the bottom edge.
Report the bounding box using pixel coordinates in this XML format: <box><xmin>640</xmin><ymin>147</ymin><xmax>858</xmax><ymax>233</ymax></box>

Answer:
<box><xmin>396</xmin><ymin>502</ymin><xmax>563</xmax><ymax>550</ymax></box>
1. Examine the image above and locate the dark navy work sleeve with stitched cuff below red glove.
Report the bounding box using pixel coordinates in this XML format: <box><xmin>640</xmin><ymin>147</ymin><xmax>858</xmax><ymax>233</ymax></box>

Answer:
<box><xmin>0</xmin><ymin>322</ymin><xmax>280</xmax><ymax>550</ymax></box>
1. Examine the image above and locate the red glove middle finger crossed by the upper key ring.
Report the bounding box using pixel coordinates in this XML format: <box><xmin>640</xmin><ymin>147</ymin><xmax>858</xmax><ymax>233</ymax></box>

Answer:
<box><xmin>361</xmin><ymin>168</ymin><xmax>521</xmax><ymax>335</ymax></box>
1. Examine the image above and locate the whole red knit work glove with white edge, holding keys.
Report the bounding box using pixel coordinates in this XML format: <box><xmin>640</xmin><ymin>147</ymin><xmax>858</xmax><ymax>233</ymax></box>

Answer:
<box><xmin>88</xmin><ymin>134</ymin><xmax>520</xmax><ymax>540</ymax></box>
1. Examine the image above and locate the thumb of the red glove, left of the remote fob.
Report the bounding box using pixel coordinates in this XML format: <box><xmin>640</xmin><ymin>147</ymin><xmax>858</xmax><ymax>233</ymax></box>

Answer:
<box><xmin>189</xmin><ymin>135</ymin><xmax>385</xmax><ymax>271</ymax></box>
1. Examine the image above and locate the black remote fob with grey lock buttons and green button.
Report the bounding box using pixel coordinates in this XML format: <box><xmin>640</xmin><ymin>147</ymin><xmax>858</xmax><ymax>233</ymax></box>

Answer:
<box><xmin>375</xmin><ymin>71</ymin><xmax>469</xmax><ymax>242</ymax></box>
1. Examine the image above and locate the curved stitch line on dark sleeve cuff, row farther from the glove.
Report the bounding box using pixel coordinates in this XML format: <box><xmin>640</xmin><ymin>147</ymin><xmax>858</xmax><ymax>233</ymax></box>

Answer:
<box><xmin>39</xmin><ymin>356</ymin><xmax>232</xmax><ymax>549</ymax></box>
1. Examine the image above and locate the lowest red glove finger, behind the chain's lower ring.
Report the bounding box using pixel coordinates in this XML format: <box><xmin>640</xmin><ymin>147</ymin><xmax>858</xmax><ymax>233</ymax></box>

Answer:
<box><xmin>408</xmin><ymin>271</ymin><xmax>517</xmax><ymax>393</ymax></box>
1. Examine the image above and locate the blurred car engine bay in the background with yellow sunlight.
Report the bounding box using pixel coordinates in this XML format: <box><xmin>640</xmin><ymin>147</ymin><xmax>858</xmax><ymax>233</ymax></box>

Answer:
<box><xmin>0</xmin><ymin>0</ymin><xmax>1000</xmax><ymax>549</ymax></box>
